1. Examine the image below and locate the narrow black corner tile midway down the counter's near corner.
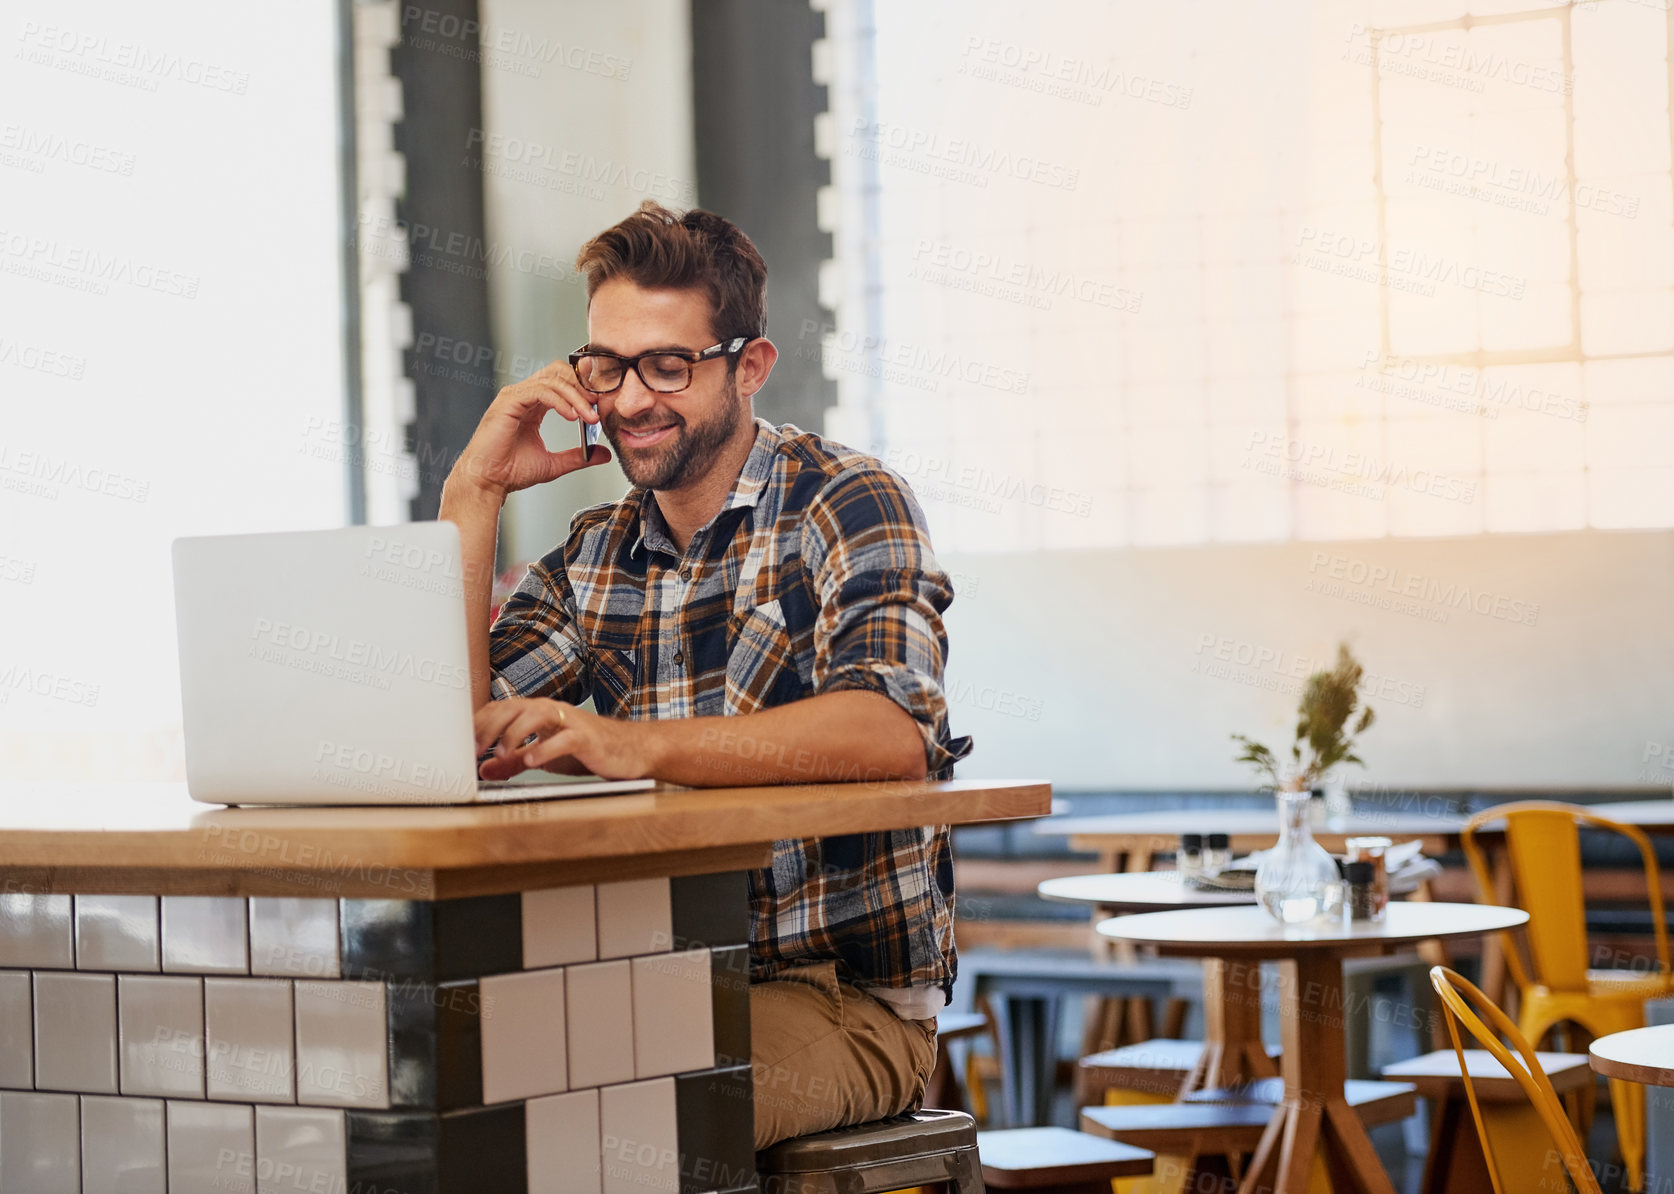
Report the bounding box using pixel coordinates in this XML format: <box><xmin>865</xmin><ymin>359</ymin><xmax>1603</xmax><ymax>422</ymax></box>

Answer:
<box><xmin>387</xmin><ymin>980</ymin><xmax>482</xmax><ymax>1110</ymax></box>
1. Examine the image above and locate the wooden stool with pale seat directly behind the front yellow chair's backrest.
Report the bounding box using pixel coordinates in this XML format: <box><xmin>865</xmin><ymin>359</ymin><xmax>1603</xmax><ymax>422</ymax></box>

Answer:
<box><xmin>1383</xmin><ymin>1048</ymin><xmax>1592</xmax><ymax>1194</ymax></box>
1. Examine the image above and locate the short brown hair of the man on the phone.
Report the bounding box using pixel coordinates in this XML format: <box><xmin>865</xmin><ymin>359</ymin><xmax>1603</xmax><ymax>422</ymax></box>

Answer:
<box><xmin>576</xmin><ymin>199</ymin><xmax>767</xmax><ymax>340</ymax></box>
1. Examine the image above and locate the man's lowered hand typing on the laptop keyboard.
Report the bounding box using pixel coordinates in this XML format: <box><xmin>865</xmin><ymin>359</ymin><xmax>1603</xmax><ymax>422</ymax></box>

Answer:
<box><xmin>475</xmin><ymin>697</ymin><xmax>650</xmax><ymax>779</ymax></box>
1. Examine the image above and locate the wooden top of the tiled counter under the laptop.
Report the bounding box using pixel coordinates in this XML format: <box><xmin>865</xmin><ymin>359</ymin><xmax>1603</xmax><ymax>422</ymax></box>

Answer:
<box><xmin>0</xmin><ymin>780</ymin><xmax>1051</xmax><ymax>899</ymax></box>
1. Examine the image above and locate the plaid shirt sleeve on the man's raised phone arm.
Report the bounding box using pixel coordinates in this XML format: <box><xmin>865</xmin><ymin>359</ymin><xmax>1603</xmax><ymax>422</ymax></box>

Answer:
<box><xmin>489</xmin><ymin>551</ymin><xmax>588</xmax><ymax>703</ymax></box>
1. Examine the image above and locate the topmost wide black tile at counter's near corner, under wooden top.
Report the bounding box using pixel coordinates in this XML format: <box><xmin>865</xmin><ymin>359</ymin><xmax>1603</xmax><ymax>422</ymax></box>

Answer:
<box><xmin>340</xmin><ymin>894</ymin><xmax>522</xmax><ymax>983</ymax></box>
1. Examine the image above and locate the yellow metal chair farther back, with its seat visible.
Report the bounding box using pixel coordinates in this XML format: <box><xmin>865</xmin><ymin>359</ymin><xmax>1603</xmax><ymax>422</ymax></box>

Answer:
<box><xmin>1461</xmin><ymin>800</ymin><xmax>1674</xmax><ymax>1189</ymax></box>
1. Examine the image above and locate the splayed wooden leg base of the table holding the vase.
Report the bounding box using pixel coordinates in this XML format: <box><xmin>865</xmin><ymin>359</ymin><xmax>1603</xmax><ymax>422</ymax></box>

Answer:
<box><xmin>1239</xmin><ymin>951</ymin><xmax>1394</xmax><ymax>1194</ymax></box>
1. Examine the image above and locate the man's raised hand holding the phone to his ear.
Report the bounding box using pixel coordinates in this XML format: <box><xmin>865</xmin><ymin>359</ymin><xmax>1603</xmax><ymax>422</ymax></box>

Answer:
<box><xmin>452</xmin><ymin>360</ymin><xmax>611</xmax><ymax>497</ymax></box>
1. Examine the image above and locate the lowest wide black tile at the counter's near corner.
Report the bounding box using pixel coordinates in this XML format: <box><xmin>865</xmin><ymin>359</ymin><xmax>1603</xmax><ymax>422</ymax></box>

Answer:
<box><xmin>347</xmin><ymin>1104</ymin><xmax>529</xmax><ymax>1194</ymax></box>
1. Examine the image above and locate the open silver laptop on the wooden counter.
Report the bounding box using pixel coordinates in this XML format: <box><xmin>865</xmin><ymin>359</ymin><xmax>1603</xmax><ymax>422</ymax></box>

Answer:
<box><xmin>174</xmin><ymin>522</ymin><xmax>656</xmax><ymax>804</ymax></box>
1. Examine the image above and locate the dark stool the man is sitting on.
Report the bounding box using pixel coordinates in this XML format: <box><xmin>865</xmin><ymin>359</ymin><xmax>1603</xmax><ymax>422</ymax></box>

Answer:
<box><xmin>755</xmin><ymin>1110</ymin><xmax>983</xmax><ymax>1194</ymax></box>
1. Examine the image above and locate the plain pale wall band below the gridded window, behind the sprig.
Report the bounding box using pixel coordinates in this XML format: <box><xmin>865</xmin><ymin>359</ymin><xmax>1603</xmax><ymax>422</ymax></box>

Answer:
<box><xmin>942</xmin><ymin>531</ymin><xmax>1674</xmax><ymax>790</ymax></box>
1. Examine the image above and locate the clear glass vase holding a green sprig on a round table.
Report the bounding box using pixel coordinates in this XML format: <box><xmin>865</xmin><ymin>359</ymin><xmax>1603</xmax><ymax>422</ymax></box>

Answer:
<box><xmin>1232</xmin><ymin>645</ymin><xmax>1373</xmax><ymax>924</ymax></box>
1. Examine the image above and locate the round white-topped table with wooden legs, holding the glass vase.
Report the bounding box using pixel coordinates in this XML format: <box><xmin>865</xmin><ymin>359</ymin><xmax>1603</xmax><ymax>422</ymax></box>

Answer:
<box><xmin>1098</xmin><ymin>903</ymin><xmax>1528</xmax><ymax>1194</ymax></box>
